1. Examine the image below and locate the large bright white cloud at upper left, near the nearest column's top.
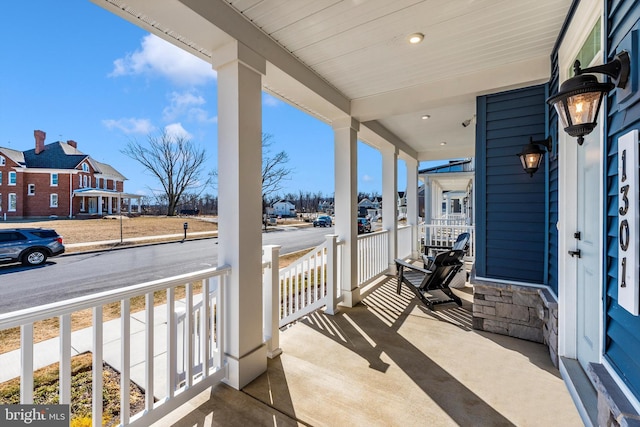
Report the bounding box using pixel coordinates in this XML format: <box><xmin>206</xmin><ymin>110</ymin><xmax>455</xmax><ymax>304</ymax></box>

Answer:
<box><xmin>109</xmin><ymin>34</ymin><xmax>216</xmax><ymax>85</ymax></box>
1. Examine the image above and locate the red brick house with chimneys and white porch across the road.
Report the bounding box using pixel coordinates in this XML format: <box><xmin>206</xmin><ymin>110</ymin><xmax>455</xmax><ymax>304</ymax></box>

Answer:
<box><xmin>0</xmin><ymin>130</ymin><xmax>141</xmax><ymax>218</ymax></box>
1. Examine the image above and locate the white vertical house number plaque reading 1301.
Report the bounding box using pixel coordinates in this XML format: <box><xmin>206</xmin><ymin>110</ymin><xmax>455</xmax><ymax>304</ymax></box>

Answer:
<box><xmin>618</xmin><ymin>130</ymin><xmax>640</xmax><ymax>316</ymax></box>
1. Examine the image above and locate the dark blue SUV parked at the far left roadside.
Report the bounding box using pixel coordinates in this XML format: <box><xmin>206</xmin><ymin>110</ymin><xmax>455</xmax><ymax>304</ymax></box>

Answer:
<box><xmin>0</xmin><ymin>228</ymin><xmax>64</xmax><ymax>265</ymax></box>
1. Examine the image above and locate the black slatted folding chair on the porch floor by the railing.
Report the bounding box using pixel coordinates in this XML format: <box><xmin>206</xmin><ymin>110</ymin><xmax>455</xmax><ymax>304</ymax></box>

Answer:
<box><xmin>395</xmin><ymin>249</ymin><xmax>464</xmax><ymax>310</ymax></box>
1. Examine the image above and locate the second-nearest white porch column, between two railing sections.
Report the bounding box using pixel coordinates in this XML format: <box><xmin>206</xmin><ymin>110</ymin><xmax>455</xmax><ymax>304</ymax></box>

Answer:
<box><xmin>333</xmin><ymin>117</ymin><xmax>360</xmax><ymax>307</ymax></box>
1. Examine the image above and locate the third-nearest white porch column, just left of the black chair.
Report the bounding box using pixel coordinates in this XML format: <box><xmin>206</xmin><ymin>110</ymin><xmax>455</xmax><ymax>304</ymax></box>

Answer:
<box><xmin>380</xmin><ymin>145</ymin><xmax>398</xmax><ymax>274</ymax></box>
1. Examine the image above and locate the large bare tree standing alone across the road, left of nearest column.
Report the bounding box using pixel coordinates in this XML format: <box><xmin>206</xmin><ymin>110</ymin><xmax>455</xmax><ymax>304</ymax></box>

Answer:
<box><xmin>122</xmin><ymin>132</ymin><xmax>208</xmax><ymax>216</ymax></box>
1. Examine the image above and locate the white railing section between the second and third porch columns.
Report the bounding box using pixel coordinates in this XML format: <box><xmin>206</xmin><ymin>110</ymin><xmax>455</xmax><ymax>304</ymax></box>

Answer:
<box><xmin>358</xmin><ymin>230</ymin><xmax>389</xmax><ymax>286</ymax></box>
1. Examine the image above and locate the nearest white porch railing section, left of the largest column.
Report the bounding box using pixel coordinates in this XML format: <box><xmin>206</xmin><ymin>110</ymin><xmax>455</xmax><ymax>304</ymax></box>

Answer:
<box><xmin>0</xmin><ymin>267</ymin><xmax>230</xmax><ymax>427</ymax></box>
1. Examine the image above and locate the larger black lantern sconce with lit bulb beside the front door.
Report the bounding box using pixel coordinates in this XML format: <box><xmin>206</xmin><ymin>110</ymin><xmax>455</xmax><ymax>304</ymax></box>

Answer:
<box><xmin>547</xmin><ymin>51</ymin><xmax>630</xmax><ymax>145</ymax></box>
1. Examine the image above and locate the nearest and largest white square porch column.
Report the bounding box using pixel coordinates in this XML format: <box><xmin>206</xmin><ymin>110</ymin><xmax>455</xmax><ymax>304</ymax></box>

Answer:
<box><xmin>212</xmin><ymin>41</ymin><xmax>267</xmax><ymax>389</ymax></box>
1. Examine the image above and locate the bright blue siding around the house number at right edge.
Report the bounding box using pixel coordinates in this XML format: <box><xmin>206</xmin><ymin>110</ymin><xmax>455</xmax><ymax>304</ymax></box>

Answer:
<box><xmin>603</xmin><ymin>0</ymin><xmax>640</xmax><ymax>399</ymax></box>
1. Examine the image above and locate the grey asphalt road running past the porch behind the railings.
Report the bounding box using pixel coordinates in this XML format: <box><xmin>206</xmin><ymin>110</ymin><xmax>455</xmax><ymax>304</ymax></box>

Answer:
<box><xmin>0</xmin><ymin>227</ymin><xmax>333</xmax><ymax>313</ymax></box>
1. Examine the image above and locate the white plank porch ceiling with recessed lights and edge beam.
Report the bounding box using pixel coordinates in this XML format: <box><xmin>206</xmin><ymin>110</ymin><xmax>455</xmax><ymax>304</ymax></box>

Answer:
<box><xmin>92</xmin><ymin>0</ymin><xmax>571</xmax><ymax>160</ymax></box>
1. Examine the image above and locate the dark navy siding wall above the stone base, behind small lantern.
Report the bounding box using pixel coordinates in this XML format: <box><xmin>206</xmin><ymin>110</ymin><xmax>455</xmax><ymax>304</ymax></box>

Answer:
<box><xmin>476</xmin><ymin>85</ymin><xmax>546</xmax><ymax>284</ymax></box>
